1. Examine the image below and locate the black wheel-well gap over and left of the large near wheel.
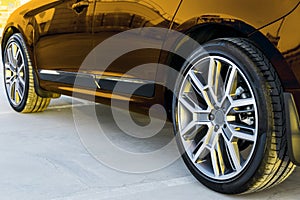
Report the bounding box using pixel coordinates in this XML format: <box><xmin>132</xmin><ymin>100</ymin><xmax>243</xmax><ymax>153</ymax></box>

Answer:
<box><xmin>164</xmin><ymin>16</ymin><xmax>300</xmax><ymax>119</ymax></box>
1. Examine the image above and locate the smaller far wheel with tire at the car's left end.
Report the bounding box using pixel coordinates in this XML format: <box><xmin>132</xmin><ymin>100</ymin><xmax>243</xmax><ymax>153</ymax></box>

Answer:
<box><xmin>3</xmin><ymin>33</ymin><xmax>50</xmax><ymax>113</ymax></box>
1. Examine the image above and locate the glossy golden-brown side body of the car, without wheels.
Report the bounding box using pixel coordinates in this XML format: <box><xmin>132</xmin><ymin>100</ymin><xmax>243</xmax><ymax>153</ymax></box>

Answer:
<box><xmin>1</xmin><ymin>0</ymin><xmax>300</xmax><ymax>164</ymax></box>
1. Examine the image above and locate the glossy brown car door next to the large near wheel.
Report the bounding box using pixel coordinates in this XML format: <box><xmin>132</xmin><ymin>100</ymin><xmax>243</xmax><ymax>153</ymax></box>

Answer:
<box><xmin>85</xmin><ymin>0</ymin><xmax>180</xmax><ymax>97</ymax></box>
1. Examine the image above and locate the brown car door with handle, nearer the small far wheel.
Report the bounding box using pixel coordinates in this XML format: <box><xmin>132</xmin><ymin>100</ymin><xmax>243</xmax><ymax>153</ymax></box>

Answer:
<box><xmin>34</xmin><ymin>0</ymin><xmax>95</xmax><ymax>73</ymax></box>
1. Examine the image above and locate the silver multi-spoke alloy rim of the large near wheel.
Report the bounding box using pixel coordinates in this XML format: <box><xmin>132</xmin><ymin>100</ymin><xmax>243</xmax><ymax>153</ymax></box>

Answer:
<box><xmin>176</xmin><ymin>56</ymin><xmax>258</xmax><ymax>180</ymax></box>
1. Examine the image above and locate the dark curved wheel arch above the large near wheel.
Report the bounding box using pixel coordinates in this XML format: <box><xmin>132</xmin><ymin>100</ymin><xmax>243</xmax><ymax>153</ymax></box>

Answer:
<box><xmin>176</xmin><ymin>19</ymin><xmax>300</xmax><ymax>89</ymax></box>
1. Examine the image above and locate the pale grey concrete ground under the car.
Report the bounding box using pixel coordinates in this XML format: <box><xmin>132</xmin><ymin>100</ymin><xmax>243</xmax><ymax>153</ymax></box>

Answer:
<box><xmin>0</xmin><ymin>67</ymin><xmax>300</xmax><ymax>200</ymax></box>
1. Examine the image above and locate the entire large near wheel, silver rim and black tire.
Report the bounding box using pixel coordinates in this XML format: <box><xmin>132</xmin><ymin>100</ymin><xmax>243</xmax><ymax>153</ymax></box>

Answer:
<box><xmin>173</xmin><ymin>38</ymin><xmax>295</xmax><ymax>194</ymax></box>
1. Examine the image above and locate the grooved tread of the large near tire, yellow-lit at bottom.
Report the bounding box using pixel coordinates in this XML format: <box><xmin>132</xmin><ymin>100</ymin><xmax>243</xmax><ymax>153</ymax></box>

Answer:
<box><xmin>220</xmin><ymin>38</ymin><xmax>295</xmax><ymax>193</ymax></box>
